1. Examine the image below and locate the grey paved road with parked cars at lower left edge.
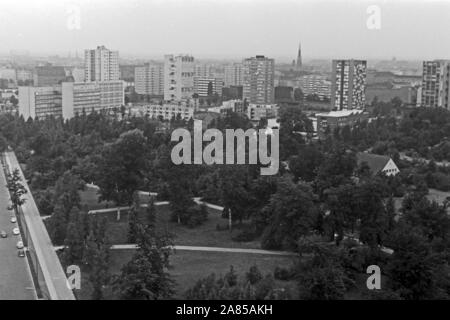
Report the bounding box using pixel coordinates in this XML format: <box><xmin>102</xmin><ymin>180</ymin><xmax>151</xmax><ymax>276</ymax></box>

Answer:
<box><xmin>0</xmin><ymin>160</ymin><xmax>36</xmax><ymax>300</ymax></box>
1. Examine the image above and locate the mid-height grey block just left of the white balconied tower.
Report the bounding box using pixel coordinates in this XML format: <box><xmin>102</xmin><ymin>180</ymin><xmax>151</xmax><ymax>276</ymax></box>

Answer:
<box><xmin>134</xmin><ymin>63</ymin><xmax>164</xmax><ymax>96</ymax></box>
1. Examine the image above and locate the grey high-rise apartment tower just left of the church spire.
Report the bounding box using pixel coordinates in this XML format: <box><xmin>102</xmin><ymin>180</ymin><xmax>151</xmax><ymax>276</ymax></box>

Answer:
<box><xmin>243</xmin><ymin>56</ymin><xmax>275</xmax><ymax>104</ymax></box>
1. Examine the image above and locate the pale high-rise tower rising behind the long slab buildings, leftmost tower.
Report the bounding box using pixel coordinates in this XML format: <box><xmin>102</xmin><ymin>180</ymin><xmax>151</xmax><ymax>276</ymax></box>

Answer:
<box><xmin>84</xmin><ymin>46</ymin><xmax>120</xmax><ymax>81</ymax></box>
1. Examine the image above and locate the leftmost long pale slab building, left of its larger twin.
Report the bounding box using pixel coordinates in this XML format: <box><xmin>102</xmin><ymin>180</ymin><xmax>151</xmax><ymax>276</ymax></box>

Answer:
<box><xmin>19</xmin><ymin>86</ymin><xmax>62</xmax><ymax>120</ymax></box>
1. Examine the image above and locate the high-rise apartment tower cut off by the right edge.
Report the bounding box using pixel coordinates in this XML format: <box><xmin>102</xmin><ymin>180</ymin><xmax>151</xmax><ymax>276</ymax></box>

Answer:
<box><xmin>420</xmin><ymin>60</ymin><xmax>450</xmax><ymax>109</ymax></box>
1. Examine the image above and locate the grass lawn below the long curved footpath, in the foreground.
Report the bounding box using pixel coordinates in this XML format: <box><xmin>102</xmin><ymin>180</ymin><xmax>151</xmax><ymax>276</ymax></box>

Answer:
<box><xmin>76</xmin><ymin>250</ymin><xmax>295</xmax><ymax>299</ymax></box>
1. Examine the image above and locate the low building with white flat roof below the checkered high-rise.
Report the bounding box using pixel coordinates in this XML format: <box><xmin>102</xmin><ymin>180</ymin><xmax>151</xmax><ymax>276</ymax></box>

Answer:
<box><xmin>316</xmin><ymin>109</ymin><xmax>369</xmax><ymax>138</ymax></box>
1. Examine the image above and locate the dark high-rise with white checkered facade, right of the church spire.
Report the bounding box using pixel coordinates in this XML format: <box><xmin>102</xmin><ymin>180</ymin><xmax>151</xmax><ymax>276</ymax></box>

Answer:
<box><xmin>331</xmin><ymin>60</ymin><xmax>367</xmax><ymax>110</ymax></box>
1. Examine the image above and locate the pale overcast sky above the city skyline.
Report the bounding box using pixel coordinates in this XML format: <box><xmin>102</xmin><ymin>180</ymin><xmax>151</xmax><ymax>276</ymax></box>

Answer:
<box><xmin>0</xmin><ymin>0</ymin><xmax>450</xmax><ymax>60</ymax></box>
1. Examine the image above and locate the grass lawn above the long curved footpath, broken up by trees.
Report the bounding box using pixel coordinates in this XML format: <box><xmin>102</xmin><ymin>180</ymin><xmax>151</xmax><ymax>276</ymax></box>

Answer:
<box><xmin>80</xmin><ymin>187</ymin><xmax>261</xmax><ymax>249</ymax></box>
